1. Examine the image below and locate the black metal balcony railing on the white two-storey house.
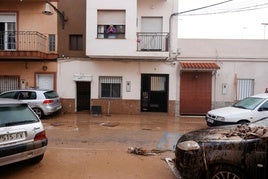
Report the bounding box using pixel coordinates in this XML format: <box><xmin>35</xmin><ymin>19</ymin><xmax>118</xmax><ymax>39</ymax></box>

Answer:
<box><xmin>137</xmin><ymin>32</ymin><xmax>168</xmax><ymax>52</ymax></box>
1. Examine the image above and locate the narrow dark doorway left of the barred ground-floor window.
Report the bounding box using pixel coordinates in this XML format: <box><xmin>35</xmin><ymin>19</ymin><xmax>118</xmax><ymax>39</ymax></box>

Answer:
<box><xmin>76</xmin><ymin>82</ymin><xmax>91</xmax><ymax>111</ymax></box>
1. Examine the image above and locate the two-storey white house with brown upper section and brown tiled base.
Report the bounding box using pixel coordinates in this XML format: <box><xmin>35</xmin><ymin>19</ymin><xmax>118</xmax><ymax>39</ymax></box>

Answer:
<box><xmin>58</xmin><ymin>0</ymin><xmax>178</xmax><ymax>115</ymax></box>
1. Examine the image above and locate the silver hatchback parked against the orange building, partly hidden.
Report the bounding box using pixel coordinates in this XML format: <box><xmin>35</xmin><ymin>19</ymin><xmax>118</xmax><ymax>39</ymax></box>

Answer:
<box><xmin>0</xmin><ymin>89</ymin><xmax>62</xmax><ymax>118</ymax></box>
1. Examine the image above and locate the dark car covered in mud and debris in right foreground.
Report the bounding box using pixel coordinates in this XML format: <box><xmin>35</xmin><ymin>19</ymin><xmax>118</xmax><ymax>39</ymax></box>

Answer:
<box><xmin>175</xmin><ymin>118</ymin><xmax>268</xmax><ymax>179</ymax></box>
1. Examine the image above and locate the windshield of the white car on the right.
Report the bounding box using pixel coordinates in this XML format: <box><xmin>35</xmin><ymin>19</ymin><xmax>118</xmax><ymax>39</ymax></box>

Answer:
<box><xmin>233</xmin><ymin>97</ymin><xmax>265</xmax><ymax>110</ymax></box>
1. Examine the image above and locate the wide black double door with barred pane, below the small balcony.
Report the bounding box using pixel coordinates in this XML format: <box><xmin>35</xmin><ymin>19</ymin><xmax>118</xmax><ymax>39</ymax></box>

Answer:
<box><xmin>141</xmin><ymin>74</ymin><xmax>168</xmax><ymax>112</ymax></box>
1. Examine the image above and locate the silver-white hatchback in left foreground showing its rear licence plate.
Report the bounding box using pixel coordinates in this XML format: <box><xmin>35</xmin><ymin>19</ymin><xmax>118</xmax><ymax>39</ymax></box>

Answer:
<box><xmin>0</xmin><ymin>99</ymin><xmax>48</xmax><ymax>166</ymax></box>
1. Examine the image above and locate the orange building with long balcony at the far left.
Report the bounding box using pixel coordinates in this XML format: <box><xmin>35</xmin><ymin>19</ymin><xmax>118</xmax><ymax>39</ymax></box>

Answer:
<box><xmin>0</xmin><ymin>0</ymin><xmax>58</xmax><ymax>92</ymax></box>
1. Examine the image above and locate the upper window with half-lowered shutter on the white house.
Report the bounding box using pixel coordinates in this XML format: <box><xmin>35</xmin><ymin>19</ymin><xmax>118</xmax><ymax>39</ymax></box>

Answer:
<box><xmin>97</xmin><ymin>10</ymin><xmax>126</xmax><ymax>39</ymax></box>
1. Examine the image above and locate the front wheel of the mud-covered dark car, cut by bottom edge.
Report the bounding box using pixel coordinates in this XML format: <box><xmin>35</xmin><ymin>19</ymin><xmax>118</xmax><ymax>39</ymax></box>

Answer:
<box><xmin>210</xmin><ymin>165</ymin><xmax>244</xmax><ymax>179</ymax></box>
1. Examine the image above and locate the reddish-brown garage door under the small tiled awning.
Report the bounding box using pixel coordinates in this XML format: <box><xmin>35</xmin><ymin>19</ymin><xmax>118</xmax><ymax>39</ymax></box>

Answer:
<box><xmin>180</xmin><ymin>72</ymin><xmax>212</xmax><ymax>115</ymax></box>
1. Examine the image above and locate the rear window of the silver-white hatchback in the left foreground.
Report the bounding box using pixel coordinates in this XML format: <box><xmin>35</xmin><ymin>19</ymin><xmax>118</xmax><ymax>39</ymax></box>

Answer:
<box><xmin>0</xmin><ymin>104</ymin><xmax>39</xmax><ymax>127</ymax></box>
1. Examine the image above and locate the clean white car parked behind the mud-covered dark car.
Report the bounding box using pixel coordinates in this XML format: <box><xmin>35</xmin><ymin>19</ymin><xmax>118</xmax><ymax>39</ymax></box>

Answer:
<box><xmin>206</xmin><ymin>93</ymin><xmax>268</xmax><ymax>126</ymax></box>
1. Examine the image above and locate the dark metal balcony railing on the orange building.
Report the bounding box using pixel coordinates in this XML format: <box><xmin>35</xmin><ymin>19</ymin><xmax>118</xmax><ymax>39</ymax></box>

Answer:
<box><xmin>0</xmin><ymin>31</ymin><xmax>47</xmax><ymax>52</ymax></box>
